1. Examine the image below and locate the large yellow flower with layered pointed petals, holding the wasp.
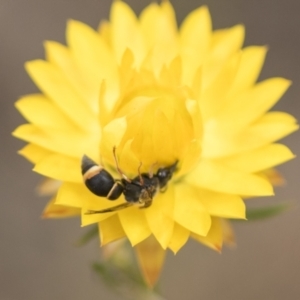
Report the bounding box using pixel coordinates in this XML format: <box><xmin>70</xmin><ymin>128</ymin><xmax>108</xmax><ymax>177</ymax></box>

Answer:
<box><xmin>14</xmin><ymin>1</ymin><xmax>298</xmax><ymax>281</ymax></box>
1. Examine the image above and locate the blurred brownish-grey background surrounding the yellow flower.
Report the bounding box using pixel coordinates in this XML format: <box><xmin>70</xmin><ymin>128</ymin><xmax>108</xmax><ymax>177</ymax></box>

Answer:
<box><xmin>0</xmin><ymin>0</ymin><xmax>300</xmax><ymax>300</ymax></box>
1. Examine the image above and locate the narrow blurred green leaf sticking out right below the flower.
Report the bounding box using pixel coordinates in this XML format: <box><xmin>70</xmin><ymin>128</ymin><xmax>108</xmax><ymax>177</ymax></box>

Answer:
<box><xmin>246</xmin><ymin>203</ymin><xmax>291</xmax><ymax>221</ymax></box>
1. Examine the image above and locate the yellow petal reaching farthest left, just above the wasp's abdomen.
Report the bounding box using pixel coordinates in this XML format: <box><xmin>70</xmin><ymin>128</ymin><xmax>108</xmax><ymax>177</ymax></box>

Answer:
<box><xmin>13</xmin><ymin>124</ymin><xmax>99</xmax><ymax>160</ymax></box>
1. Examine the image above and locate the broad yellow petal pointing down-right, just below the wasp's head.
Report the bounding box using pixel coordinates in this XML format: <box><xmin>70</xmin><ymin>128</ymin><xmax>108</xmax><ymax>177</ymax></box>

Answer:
<box><xmin>174</xmin><ymin>183</ymin><xmax>211</xmax><ymax>236</ymax></box>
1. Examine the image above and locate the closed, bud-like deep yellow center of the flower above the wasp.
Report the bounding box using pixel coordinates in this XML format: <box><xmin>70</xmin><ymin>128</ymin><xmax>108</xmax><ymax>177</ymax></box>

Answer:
<box><xmin>112</xmin><ymin>87</ymin><xmax>194</xmax><ymax>171</ymax></box>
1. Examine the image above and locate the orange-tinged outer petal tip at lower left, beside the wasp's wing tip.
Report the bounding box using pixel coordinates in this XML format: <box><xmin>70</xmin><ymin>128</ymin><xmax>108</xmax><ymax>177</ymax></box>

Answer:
<box><xmin>42</xmin><ymin>198</ymin><xmax>80</xmax><ymax>219</ymax></box>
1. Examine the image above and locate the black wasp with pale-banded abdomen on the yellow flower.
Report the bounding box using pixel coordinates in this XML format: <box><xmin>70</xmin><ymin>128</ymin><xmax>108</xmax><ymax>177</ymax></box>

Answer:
<box><xmin>81</xmin><ymin>147</ymin><xmax>178</xmax><ymax>214</ymax></box>
